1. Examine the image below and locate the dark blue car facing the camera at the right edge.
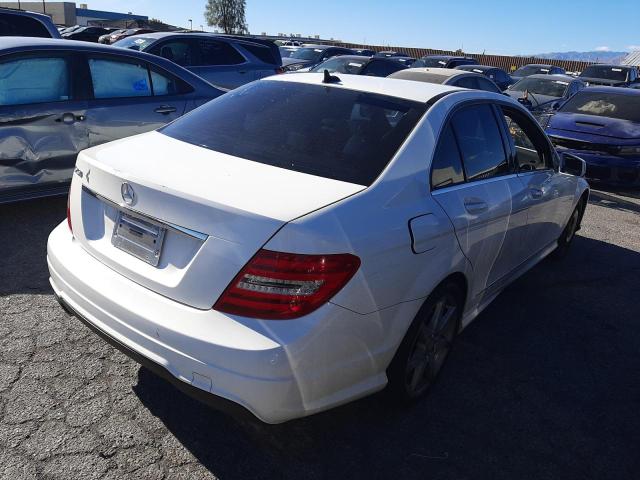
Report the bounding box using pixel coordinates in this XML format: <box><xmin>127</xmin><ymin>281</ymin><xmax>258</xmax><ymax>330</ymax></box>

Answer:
<box><xmin>546</xmin><ymin>87</ymin><xmax>640</xmax><ymax>187</ymax></box>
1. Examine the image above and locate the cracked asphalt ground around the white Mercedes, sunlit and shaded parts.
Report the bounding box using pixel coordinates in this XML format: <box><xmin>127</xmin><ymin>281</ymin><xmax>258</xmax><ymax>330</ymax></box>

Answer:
<box><xmin>0</xmin><ymin>192</ymin><xmax>640</xmax><ymax>480</ymax></box>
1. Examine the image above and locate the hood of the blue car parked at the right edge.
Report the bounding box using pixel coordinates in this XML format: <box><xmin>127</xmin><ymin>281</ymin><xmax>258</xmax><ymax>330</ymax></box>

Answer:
<box><xmin>548</xmin><ymin>112</ymin><xmax>640</xmax><ymax>140</ymax></box>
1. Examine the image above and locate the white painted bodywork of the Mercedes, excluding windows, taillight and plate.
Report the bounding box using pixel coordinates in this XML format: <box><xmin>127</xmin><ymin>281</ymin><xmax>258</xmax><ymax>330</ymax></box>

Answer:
<box><xmin>48</xmin><ymin>74</ymin><xmax>588</xmax><ymax>423</ymax></box>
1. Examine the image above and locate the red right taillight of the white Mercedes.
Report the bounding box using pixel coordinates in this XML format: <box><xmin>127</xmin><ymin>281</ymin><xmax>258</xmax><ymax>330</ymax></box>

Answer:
<box><xmin>213</xmin><ymin>250</ymin><xmax>360</xmax><ymax>320</ymax></box>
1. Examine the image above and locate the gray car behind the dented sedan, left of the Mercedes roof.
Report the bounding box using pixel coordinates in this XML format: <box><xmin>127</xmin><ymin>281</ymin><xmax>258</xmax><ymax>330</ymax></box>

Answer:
<box><xmin>113</xmin><ymin>32</ymin><xmax>282</xmax><ymax>89</ymax></box>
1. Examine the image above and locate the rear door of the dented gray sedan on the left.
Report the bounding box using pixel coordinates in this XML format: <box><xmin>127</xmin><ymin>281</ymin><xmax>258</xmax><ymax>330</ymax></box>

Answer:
<box><xmin>86</xmin><ymin>55</ymin><xmax>187</xmax><ymax>146</ymax></box>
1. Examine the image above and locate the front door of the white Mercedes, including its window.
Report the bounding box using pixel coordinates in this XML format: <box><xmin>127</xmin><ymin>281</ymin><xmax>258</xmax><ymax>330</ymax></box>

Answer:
<box><xmin>501</xmin><ymin>106</ymin><xmax>575</xmax><ymax>257</ymax></box>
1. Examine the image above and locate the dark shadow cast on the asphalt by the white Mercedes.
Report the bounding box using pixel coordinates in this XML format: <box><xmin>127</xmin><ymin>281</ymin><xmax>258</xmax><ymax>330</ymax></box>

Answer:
<box><xmin>134</xmin><ymin>236</ymin><xmax>640</xmax><ymax>479</ymax></box>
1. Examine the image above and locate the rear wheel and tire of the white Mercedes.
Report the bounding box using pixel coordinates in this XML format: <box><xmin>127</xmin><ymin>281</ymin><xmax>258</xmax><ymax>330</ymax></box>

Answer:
<box><xmin>387</xmin><ymin>282</ymin><xmax>464</xmax><ymax>403</ymax></box>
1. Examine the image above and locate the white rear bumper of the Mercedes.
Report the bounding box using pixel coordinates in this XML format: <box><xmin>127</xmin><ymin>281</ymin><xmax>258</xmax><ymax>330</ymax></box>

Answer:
<box><xmin>47</xmin><ymin>222</ymin><xmax>386</xmax><ymax>423</ymax></box>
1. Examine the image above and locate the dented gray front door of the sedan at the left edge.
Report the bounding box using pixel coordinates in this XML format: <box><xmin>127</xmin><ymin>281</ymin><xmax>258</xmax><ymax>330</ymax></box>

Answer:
<box><xmin>0</xmin><ymin>52</ymin><xmax>88</xmax><ymax>201</ymax></box>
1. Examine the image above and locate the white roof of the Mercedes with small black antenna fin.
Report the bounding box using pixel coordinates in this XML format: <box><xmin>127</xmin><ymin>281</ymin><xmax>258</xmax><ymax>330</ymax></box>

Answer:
<box><xmin>266</xmin><ymin>70</ymin><xmax>470</xmax><ymax>103</ymax></box>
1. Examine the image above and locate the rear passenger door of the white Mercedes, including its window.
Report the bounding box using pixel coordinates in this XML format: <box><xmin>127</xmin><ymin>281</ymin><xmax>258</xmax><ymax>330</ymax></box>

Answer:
<box><xmin>431</xmin><ymin>103</ymin><xmax>526</xmax><ymax>297</ymax></box>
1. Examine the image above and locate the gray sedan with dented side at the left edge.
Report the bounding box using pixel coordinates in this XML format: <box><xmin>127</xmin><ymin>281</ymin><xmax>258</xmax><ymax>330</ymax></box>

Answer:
<box><xmin>0</xmin><ymin>37</ymin><xmax>224</xmax><ymax>203</ymax></box>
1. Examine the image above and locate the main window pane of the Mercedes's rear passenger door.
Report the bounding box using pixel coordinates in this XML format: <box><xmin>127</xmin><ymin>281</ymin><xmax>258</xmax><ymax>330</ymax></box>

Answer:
<box><xmin>451</xmin><ymin>104</ymin><xmax>510</xmax><ymax>181</ymax></box>
